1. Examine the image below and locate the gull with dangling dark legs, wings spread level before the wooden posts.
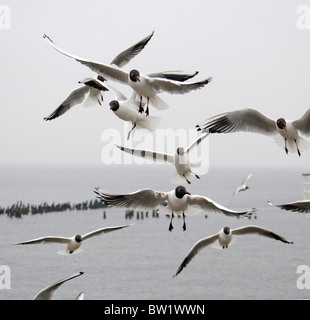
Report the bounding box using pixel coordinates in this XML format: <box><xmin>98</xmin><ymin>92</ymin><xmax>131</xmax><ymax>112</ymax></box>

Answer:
<box><xmin>95</xmin><ymin>186</ymin><xmax>256</xmax><ymax>231</ymax></box>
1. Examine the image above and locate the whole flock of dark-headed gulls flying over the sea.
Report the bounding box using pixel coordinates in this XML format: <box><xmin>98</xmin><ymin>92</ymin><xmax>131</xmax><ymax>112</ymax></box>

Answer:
<box><xmin>13</xmin><ymin>32</ymin><xmax>310</xmax><ymax>299</ymax></box>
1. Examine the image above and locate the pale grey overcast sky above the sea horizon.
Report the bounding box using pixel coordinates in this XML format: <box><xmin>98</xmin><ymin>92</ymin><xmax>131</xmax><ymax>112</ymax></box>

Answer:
<box><xmin>0</xmin><ymin>0</ymin><xmax>310</xmax><ymax>167</ymax></box>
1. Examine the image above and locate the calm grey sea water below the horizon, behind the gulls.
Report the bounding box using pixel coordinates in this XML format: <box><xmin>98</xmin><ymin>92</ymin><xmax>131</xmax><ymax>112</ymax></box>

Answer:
<box><xmin>0</xmin><ymin>165</ymin><xmax>310</xmax><ymax>300</ymax></box>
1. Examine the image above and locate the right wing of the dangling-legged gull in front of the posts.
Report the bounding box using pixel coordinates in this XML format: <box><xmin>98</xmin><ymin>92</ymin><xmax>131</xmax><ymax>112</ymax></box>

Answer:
<box><xmin>188</xmin><ymin>195</ymin><xmax>256</xmax><ymax>218</ymax></box>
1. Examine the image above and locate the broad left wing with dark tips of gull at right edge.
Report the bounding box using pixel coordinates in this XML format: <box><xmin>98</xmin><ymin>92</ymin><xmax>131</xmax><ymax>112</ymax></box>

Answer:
<box><xmin>196</xmin><ymin>109</ymin><xmax>277</xmax><ymax>135</ymax></box>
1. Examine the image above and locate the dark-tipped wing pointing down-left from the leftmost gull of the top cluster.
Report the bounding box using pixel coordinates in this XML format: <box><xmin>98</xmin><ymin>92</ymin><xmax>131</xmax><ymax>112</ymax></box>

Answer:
<box><xmin>44</xmin><ymin>86</ymin><xmax>89</xmax><ymax>121</ymax></box>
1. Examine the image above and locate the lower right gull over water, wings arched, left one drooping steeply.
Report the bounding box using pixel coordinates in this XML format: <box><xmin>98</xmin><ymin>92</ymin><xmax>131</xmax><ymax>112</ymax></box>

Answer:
<box><xmin>173</xmin><ymin>225</ymin><xmax>293</xmax><ymax>277</ymax></box>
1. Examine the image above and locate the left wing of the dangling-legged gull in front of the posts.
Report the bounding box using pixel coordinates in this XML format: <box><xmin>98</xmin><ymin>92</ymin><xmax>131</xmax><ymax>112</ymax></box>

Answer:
<box><xmin>95</xmin><ymin>188</ymin><xmax>168</xmax><ymax>209</ymax></box>
